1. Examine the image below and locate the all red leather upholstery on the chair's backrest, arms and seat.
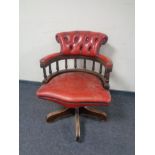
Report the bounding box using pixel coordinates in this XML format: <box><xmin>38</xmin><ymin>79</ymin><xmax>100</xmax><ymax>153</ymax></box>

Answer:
<box><xmin>37</xmin><ymin>31</ymin><xmax>112</xmax><ymax>108</ymax></box>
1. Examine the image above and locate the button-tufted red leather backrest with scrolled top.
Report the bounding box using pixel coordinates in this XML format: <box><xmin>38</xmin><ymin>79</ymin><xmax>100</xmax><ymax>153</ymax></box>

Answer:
<box><xmin>56</xmin><ymin>31</ymin><xmax>108</xmax><ymax>56</ymax></box>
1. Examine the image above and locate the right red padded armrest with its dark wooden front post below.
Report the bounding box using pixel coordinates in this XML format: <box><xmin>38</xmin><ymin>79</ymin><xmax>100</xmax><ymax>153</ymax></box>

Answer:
<box><xmin>97</xmin><ymin>54</ymin><xmax>113</xmax><ymax>89</ymax></box>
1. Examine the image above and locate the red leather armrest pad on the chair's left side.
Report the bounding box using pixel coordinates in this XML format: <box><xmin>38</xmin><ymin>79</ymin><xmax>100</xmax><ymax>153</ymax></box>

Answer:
<box><xmin>40</xmin><ymin>53</ymin><xmax>62</xmax><ymax>67</ymax></box>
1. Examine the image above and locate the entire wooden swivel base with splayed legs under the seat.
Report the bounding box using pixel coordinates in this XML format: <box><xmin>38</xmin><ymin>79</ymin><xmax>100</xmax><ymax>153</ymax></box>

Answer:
<box><xmin>46</xmin><ymin>107</ymin><xmax>107</xmax><ymax>141</ymax></box>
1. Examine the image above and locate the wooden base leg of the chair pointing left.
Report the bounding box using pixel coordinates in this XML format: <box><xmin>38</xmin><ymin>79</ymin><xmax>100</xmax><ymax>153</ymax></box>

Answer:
<box><xmin>46</xmin><ymin>108</ymin><xmax>75</xmax><ymax>123</ymax></box>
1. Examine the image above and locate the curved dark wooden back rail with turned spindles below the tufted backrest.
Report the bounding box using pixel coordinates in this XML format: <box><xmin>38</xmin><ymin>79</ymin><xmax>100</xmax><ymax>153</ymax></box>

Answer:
<box><xmin>40</xmin><ymin>55</ymin><xmax>112</xmax><ymax>89</ymax></box>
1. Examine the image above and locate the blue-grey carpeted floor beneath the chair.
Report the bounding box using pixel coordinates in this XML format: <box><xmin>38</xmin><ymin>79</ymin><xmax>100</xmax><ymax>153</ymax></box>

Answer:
<box><xmin>19</xmin><ymin>81</ymin><xmax>135</xmax><ymax>155</ymax></box>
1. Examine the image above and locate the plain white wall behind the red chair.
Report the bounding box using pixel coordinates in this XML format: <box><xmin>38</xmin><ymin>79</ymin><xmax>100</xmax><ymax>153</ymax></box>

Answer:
<box><xmin>19</xmin><ymin>0</ymin><xmax>135</xmax><ymax>91</ymax></box>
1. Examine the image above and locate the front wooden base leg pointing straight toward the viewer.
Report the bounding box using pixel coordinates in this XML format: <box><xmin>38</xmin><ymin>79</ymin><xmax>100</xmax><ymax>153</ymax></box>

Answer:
<box><xmin>75</xmin><ymin>108</ymin><xmax>80</xmax><ymax>141</ymax></box>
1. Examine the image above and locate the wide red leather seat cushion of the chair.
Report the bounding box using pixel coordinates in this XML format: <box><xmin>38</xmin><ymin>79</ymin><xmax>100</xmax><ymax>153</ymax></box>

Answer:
<box><xmin>37</xmin><ymin>72</ymin><xmax>111</xmax><ymax>107</ymax></box>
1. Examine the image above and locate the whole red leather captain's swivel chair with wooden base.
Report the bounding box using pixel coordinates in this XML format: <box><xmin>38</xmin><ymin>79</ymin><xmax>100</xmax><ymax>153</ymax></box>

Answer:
<box><xmin>37</xmin><ymin>31</ymin><xmax>112</xmax><ymax>140</ymax></box>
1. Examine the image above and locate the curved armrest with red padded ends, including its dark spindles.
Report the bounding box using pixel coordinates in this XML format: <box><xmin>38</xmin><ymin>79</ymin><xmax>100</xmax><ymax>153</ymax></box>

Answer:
<box><xmin>40</xmin><ymin>53</ymin><xmax>113</xmax><ymax>89</ymax></box>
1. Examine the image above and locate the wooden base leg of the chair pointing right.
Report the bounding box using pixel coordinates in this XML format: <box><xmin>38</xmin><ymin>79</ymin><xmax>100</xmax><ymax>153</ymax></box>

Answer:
<box><xmin>80</xmin><ymin>107</ymin><xmax>107</xmax><ymax>120</ymax></box>
